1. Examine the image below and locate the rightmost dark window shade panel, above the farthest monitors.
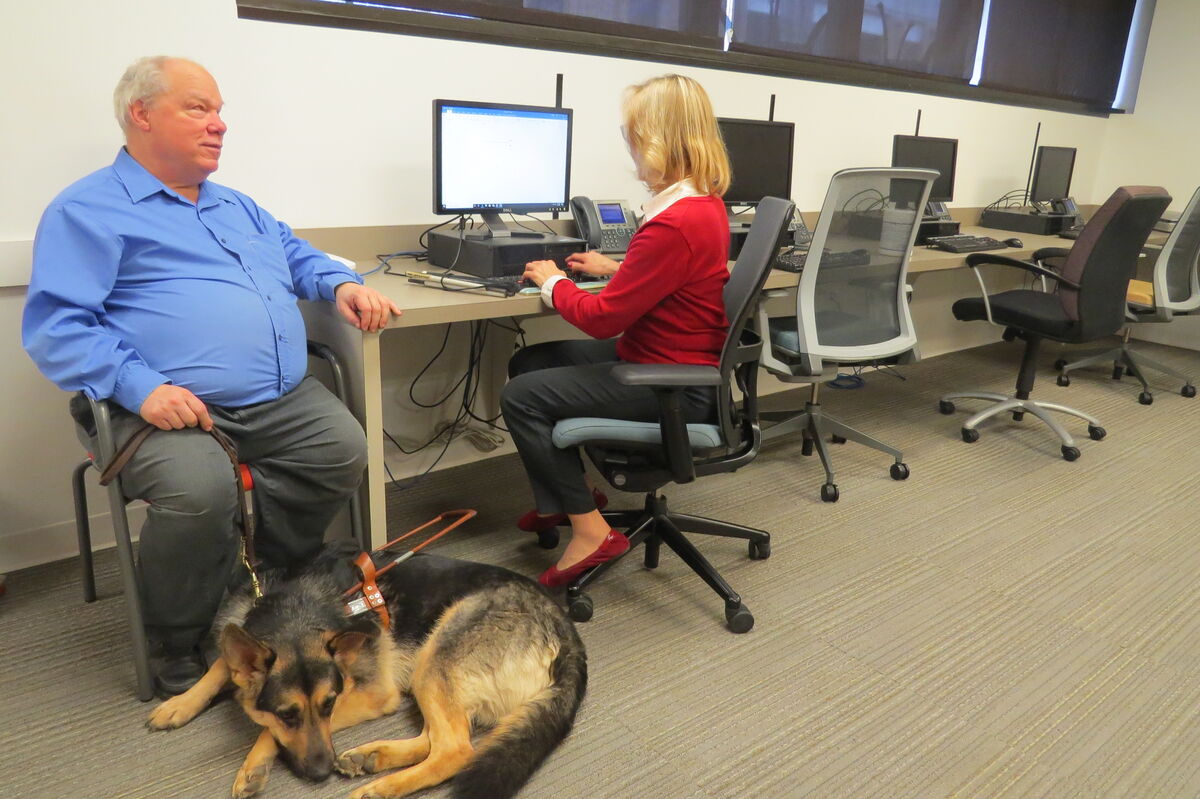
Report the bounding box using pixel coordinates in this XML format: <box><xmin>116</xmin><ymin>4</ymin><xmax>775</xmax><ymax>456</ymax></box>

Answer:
<box><xmin>980</xmin><ymin>0</ymin><xmax>1136</xmax><ymax>108</ymax></box>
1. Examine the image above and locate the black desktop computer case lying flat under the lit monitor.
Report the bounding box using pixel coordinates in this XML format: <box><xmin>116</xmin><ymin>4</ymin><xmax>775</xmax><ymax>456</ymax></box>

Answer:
<box><xmin>430</xmin><ymin>230</ymin><xmax>587</xmax><ymax>277</ymax></box>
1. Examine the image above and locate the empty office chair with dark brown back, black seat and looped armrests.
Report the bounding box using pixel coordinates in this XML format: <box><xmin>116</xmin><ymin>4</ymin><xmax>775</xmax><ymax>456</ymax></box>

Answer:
<box><xmin>938</xmin><ymin>186</ymin><xmax>1171</xmax><ymax>461</ymax></box>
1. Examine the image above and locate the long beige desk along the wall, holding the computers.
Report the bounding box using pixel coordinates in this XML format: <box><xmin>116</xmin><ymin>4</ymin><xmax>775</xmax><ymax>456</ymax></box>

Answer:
<box><xmin>301</xmin><ymin>227</ymin><xmax>1073</xmax><ymax>546</ymax></box>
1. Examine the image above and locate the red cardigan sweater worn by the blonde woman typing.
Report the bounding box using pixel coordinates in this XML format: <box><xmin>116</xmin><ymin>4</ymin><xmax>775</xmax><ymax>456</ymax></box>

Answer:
<box><xmin>554</xmin><ymin>197</ymin><xmax>730</xmax><ymax>366</ymax></box>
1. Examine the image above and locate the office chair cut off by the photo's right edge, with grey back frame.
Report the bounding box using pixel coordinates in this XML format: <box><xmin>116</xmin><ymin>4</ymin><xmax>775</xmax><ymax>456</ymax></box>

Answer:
<box><xmin>1055</xmin><ymin>188</ymin><xmax>1200</xmax><ymax>405</ymax></box>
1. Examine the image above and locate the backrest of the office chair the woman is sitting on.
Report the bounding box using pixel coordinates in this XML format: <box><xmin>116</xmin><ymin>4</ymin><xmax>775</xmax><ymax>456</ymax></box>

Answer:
<box><xmin>718</xmin><ymin>197</ymin><xmax>796</xmax><ymax>446</ymax></box>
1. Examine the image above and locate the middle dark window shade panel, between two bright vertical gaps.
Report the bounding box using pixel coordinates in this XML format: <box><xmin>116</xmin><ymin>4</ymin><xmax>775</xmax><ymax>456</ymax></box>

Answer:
<box><xmin>730</xmin><ymin>0</ymin><xmax>983</xmax><ymax>82</ymax></box>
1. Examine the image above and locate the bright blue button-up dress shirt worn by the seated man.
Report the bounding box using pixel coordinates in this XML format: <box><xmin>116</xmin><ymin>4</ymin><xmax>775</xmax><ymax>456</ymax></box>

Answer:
<box><xmin>22</xmin><ymin>148</ymin><xmax>362</xmax><ymax>413</ymax></box>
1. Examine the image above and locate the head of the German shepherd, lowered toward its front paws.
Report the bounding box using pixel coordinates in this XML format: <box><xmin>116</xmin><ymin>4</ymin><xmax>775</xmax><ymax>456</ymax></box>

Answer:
<box><xmin>221</xmin><ymin>624</ymin><xmax>379</xmax><ymax>782</ymax></box>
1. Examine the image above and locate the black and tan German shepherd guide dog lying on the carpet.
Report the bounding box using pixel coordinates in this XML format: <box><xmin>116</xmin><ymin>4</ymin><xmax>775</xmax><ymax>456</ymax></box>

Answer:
<box><xmin>148</xmin><ymin>546</ymin><xmax>587</xmax><ymax>799</ymax></box>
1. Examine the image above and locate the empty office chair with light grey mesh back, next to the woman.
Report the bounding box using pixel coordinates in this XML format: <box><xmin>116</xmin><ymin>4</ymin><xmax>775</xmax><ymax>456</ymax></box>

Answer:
<box><xmin>758</xmin><ymin>168</ymin><xmax>937</xmax><ymax>503</ymax></box>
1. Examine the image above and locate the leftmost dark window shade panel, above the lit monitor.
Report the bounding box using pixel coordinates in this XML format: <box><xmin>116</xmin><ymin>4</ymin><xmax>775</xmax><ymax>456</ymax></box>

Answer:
<box><xmin>373</xmin><ymin>0</ymin><xmax>725</xmax><ymax>48</ymax></box>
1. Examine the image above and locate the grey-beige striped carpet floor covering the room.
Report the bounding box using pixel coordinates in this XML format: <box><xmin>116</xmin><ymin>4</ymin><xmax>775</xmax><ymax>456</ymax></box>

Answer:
<box><xmin>0</xmin><ymin>343</ymin><xmax>1200</xmax><ymax>799</ymax></box>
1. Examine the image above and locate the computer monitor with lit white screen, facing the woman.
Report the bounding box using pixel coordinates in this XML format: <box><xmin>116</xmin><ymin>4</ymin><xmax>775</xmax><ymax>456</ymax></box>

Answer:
<box><xmin>433</xmin><ymin>100</ymin><xmax>571</xmax><ymax>238</ymax></box>
